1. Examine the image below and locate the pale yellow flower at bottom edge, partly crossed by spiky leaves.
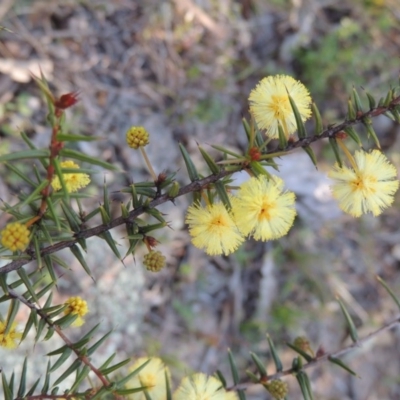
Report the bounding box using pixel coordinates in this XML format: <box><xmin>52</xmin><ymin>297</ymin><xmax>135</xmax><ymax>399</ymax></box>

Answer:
<box><xmin>127</xmin><ymin>357</ymin><xmax>171</xmax><ymax>400</ymax></box>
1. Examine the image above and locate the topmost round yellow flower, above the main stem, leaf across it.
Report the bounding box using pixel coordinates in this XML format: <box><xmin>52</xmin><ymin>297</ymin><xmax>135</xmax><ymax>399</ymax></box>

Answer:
<box><xmin>249</xmin><ymin>75</ymin><xmax>311</xmax><ymax>138</ymax></box>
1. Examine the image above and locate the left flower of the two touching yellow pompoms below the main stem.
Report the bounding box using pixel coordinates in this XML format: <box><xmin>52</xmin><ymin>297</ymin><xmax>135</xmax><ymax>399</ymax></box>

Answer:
<box><xmin>186</xmin><ymin>203</ymin><xmax>244</xmax><ymax>256</ymax></box>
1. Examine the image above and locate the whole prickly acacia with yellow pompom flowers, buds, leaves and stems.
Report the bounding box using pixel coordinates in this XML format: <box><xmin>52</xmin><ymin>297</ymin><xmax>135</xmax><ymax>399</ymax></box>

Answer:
<box><xmin>0</xmin><ymin>75</ymin><xmax>400</xmax><ymax>400</ymax></box>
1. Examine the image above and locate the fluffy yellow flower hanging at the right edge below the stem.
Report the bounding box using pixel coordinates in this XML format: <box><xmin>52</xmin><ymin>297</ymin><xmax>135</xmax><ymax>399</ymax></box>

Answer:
<box><xmin>328</xmin><ymin>150</ymin><xmax>399</xmax><ymax>217</ymax></box>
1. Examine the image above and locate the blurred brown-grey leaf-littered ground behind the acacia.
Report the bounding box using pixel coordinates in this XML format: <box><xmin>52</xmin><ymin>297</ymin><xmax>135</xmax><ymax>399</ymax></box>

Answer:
<box><xmin>0</xmin><ymin>0</ymin><xmax>400</xmax><ymax>400</ymax></box>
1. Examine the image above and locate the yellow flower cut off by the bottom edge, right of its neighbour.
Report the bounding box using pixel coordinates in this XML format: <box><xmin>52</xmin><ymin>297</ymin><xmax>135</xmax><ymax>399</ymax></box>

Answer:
<box><xmin>173</xmin><ymin>373</ymin><xmax>238</xmax><ymax>400</ymax></box>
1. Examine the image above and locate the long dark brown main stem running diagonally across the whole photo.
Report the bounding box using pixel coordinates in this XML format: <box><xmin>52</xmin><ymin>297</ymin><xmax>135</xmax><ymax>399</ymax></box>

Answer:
<box><xmin>0</xmin><ymin>96</ymin><xmax>400</xmax><ymax>274</ymax></box>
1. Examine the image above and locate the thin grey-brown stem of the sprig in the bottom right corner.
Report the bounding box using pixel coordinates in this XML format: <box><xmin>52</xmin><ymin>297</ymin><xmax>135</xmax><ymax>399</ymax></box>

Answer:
<box><xmin>227</xmin><ymin>317</ymin><xmax>400</xmax><ymax>390</ymax></box>
